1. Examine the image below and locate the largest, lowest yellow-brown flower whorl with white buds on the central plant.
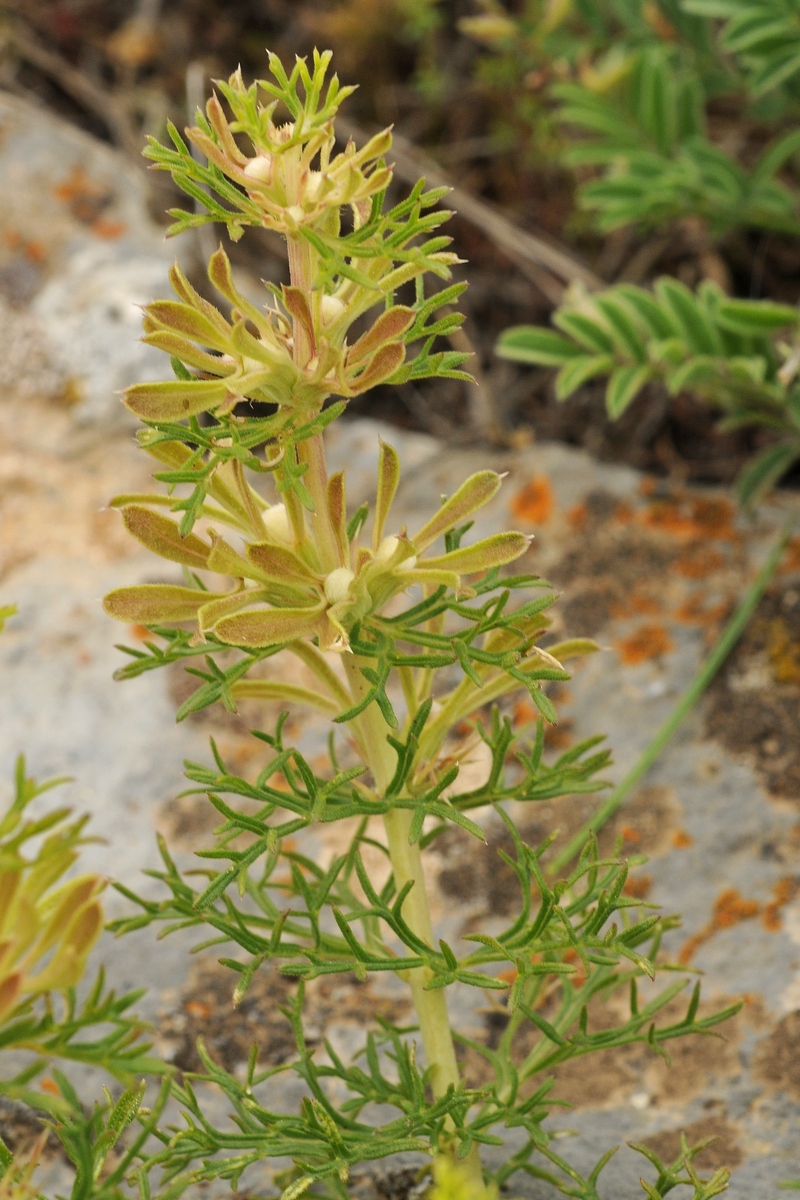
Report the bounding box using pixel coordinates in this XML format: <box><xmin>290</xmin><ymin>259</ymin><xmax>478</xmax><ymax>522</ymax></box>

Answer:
<box><xmin>106</xmin><ymin>444</ymin><xmax>529</xmax><ymax>650</ymax></box>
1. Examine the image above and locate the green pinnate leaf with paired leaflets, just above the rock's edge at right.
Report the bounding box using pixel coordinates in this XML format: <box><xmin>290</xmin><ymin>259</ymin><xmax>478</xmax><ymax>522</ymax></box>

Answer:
<box><xmin>499</xmin><ymin>277</ymin><xmax>800</xmax><ymax>504</ymax></box>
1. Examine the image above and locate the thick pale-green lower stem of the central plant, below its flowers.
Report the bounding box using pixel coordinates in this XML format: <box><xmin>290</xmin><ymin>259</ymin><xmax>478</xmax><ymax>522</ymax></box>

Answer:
<box><xmin>344</xmin><ymin>654</ymin><xmax>483</xmax><ymax>1189</ymax></box>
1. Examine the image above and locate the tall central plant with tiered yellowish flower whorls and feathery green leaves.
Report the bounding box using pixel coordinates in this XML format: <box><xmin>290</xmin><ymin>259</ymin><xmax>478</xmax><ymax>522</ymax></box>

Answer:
<box><xmin>106</xmin><ymin>54</ymin><xmax>738</xmax><ymax>1200</ymax></box>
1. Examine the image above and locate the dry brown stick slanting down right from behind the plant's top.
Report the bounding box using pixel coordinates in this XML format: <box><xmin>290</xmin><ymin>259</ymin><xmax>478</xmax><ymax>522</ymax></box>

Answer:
<box><xmin>337</xmin><ymin>116</ymin><xmax>606</xmax><ymax>305</ymax></box>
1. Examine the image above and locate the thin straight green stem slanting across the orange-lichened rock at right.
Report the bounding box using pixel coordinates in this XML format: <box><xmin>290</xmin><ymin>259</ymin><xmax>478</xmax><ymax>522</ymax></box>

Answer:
<box><xmin>547</xmin><ymin>511</ymin><xmax>798</xmax><ymax>875</ymax></box>
